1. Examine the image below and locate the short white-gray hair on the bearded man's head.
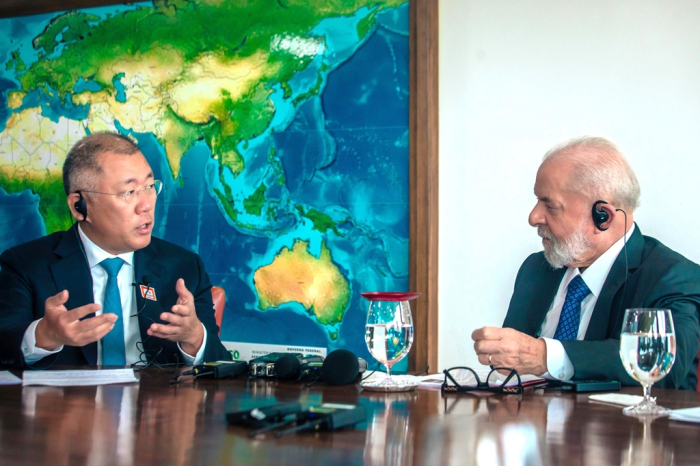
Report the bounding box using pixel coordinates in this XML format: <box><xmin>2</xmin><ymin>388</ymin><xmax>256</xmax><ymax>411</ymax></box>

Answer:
<box><xmin>542</xmin><ymin>136</ymin><xmax>640</xmax><ymax>213</ymax></box>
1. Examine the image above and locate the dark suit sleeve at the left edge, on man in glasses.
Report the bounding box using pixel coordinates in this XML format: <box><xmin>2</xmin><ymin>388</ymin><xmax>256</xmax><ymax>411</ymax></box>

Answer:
<box><xmin>0</xmin><ymin>249</ymin><xmax>41</xmax><ymax>367</ymax></box>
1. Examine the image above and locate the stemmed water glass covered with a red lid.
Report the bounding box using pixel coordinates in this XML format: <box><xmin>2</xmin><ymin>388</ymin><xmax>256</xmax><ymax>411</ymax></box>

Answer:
<box><xmin>361</xmin><ymin>292</ymin><xmax>420</xmax><ymax>387</ymax></box>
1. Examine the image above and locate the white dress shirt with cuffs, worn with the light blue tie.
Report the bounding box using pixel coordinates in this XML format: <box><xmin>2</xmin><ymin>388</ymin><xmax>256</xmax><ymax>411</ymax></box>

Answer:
<box><xmin>22</xmin><ymin>225</ymin><xmax>207</xmax><ymax>365</ymax></box>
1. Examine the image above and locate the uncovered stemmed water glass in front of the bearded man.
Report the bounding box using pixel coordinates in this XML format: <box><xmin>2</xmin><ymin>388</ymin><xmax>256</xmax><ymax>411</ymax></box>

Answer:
<box><xmin>620</xmin><ymin>309</ymin><xmax>676</xmax><ymax>416</ymax></box>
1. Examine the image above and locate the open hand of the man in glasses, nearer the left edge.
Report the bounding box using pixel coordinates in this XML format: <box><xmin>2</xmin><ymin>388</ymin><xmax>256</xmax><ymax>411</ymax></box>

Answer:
<box><xmin>35</xmin><ymin>290</ymin><xmax>117</xmax><ymax>351</ymax></box>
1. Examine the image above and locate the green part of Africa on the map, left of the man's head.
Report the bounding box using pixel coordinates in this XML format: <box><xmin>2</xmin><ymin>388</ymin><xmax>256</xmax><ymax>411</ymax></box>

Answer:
<box><xmin>0</xmin><ymin>176</ymin><xmax>72</xmax><ymax>234</ymax></box>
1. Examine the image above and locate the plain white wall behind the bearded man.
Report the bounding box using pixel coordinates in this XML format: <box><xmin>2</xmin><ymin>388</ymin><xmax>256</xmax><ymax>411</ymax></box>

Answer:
<box><xmin>439</xmin><ymin>0</ymin><xmax>700</xmax><ymax>370</ymax></box>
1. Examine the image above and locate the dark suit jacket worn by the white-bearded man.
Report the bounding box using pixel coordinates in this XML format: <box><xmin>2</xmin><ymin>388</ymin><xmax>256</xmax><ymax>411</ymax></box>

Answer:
<box><xmin>503</xmin><ymin>226</ymin><xmax>700</xmax><ymax>390</ymax></box>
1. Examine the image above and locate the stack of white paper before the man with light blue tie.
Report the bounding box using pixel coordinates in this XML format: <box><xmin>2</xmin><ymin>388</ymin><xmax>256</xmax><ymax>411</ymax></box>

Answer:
<box><xmin>22</xmin><ymin>369</ymin><xmax>139</xmax><ymax>387</ymax></box>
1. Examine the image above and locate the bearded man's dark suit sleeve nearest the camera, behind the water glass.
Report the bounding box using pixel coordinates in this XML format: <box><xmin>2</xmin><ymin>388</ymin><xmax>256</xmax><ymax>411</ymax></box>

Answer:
<box><xmin>562</xmin><ymin>260</ymin><xmax>700</xmax><ymax>390</ymax></box>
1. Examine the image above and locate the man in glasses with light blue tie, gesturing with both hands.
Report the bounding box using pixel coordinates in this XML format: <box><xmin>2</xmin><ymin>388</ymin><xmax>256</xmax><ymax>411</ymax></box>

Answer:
<box><xmin>0</xmin><ymin>133</ymin><xmax>231</xmax><ymax>367</ymax></box>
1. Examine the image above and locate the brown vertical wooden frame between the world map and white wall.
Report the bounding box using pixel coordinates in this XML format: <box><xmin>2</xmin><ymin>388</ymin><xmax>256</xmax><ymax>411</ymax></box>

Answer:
<box><xmin>409</xmin><ymin>0</ymin><xmax>439</xmax><ymax>372</ymax></box>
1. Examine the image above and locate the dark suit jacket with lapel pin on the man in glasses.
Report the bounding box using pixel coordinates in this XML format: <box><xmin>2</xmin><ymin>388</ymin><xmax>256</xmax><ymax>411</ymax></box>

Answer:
<box><xmin>0</xmin><ymin>225</ymin><xmax>231</xmax><ymax>367</ymax></box>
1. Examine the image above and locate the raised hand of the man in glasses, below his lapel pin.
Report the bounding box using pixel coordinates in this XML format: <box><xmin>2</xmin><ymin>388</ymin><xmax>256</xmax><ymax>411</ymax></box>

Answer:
<box><xmin>147</xmin><ymin>278</ymin><xmax>204</xmax><ymax>356</ymax></box>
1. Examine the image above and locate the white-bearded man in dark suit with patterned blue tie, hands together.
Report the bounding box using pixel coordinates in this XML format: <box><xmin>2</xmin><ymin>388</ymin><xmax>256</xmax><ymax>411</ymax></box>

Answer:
<box><xmin>472</xmin><ymin>137</ymin><xmax>700</xmax><ymax>390</ymax></box>
